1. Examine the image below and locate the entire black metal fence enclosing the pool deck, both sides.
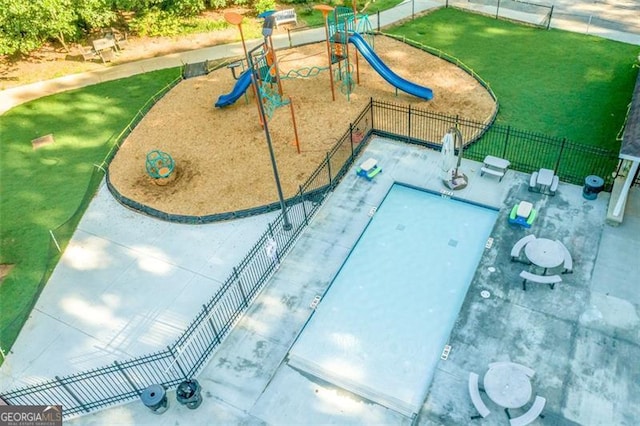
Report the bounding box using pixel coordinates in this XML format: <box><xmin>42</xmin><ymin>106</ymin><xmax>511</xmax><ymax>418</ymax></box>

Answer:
<box><xmin>1</xmin><ymin>99</ymin><xmax>617</xmax><ymax>418</ymax></box>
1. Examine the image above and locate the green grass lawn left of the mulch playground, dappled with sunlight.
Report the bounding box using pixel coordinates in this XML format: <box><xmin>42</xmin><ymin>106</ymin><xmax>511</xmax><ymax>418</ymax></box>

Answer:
<box><xmin>0</xmin><ymin>68</ymin><xmax>179</xmax><ymax>358</ymax></box>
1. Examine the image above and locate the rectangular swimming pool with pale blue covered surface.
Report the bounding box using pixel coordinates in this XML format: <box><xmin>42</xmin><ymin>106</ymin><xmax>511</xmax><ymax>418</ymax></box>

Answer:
<box><xmin>288</xmin><ymin>184</ymin><xmax>498</xmax><ymax>416</ymax></box>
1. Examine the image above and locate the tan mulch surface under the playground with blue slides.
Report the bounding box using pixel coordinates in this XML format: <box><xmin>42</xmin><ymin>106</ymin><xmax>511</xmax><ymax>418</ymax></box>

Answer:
<box><xmin>109</xmin><ymin>36</ymin><xmax>496</xmax><ymax>216</ymax></box>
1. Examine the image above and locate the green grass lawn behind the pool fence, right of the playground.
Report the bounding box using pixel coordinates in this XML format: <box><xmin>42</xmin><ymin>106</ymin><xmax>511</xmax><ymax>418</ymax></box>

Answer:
<box><xmin>388</xmin><ymin>8</ymin><xmax>640</xmax><ymax>150</ymax></box>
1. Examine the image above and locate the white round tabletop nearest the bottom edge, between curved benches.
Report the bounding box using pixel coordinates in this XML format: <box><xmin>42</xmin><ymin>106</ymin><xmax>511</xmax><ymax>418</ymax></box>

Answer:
<box><xmin>484</xmin><ymin>363</ymin><xmax>532</xmax><ymax>408</ymax></box>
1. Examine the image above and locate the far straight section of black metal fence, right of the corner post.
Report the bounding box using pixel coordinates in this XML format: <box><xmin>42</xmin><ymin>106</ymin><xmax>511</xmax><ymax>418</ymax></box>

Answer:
<box><xmin>371</xmin><ymin>100</ymin><xmax>618</xmax><ymax>191</ymax></box>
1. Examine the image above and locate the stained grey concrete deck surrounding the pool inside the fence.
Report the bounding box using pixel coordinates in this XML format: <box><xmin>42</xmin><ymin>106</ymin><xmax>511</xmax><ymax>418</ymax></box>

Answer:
<box><xmin>50</xmin><ymin>139</ymin><xmax>640</xmax><ymax>425</ymax></box>
